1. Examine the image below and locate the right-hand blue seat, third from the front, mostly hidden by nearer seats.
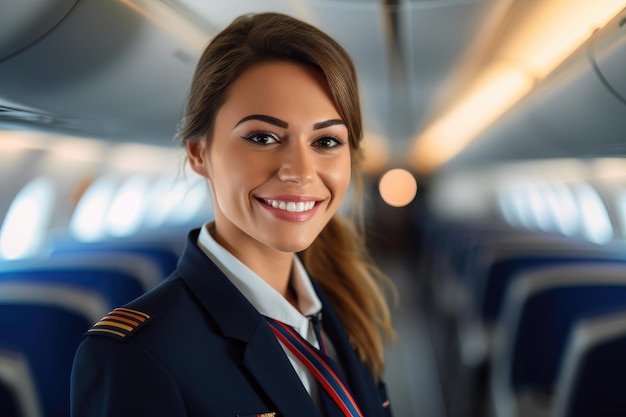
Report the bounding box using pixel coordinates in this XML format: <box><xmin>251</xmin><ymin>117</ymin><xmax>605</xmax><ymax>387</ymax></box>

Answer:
<box><xmin>454</xmin><ymin>244</ymin><xmax>619</xmax><ymax>416</ymax></box>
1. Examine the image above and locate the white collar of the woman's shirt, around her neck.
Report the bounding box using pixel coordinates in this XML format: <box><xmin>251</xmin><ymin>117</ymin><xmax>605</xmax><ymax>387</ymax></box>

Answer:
<box><xmin>198</xmin><ymin>222</ymin><xmax>322</xmax><ymax>331</ymax></box>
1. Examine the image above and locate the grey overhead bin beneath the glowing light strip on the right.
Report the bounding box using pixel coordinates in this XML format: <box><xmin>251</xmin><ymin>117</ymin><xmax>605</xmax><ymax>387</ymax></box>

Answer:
<box><xmin>445</xmin><ymin>9</ymin><xmax>626</xmax><ymax>169</ymax></box>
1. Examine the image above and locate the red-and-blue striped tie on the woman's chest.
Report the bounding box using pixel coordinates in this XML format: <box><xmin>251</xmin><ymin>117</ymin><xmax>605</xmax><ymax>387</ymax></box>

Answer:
<box><xmin>267</xmin><ymin>318</ymin><xmax>363</xmax><ymax>417</ymax></box>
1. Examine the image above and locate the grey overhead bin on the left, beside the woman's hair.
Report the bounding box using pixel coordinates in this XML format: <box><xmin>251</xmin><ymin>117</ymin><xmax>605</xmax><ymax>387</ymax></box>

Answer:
<box><xmin>0</xmin><ymin>0</ymin><xmax>208</xmax><ymax>144</ymax></box>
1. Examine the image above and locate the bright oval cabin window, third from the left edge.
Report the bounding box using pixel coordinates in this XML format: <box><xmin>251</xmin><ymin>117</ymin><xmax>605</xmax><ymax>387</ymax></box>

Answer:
<box><xmin>105</xmin><ymin>175</ymin><xmax>149</xmax><ymax>237</ymax></box>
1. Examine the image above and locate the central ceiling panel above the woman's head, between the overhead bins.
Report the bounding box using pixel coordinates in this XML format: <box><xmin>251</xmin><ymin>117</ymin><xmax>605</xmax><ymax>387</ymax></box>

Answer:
<box><xmin>169</xmin><ymin>0</ymin><xmax>510</xmax><ymax>159</ymax></box>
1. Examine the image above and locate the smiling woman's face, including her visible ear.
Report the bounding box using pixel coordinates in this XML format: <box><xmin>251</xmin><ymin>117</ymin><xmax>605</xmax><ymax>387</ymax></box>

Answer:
<box><xmin>188</xmin><ymin>62</ymin><xmax>351</xmax><ymax>253</ymax></box>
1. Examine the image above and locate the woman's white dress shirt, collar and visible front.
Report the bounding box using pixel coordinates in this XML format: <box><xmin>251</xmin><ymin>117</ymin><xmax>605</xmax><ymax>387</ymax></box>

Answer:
<box><xmin>198</xmin><ymin>222</ymin><xmax>337</xmax><ymax>400</ymax></box>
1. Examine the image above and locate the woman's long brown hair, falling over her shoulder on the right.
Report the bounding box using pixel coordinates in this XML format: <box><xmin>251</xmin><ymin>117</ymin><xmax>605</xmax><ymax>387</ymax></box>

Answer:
<box><xmin>178</xmin><ymin>13</ymin><xmax>393</xmax><ymax>375</ymax></box>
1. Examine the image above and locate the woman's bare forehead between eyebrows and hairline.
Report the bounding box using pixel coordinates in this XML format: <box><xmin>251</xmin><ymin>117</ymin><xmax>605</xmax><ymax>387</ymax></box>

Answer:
<box><xmin>218</xmin><ymin>61</ymin><xmax>340</xmax><ymax>122</ymax></box>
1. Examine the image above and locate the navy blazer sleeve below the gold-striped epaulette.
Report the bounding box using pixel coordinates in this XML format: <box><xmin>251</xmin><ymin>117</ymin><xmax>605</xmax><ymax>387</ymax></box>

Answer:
<box><xmin>70</xmin><ymin>336</ymin><xmax>187</xmax><ymax>417</ymax></box>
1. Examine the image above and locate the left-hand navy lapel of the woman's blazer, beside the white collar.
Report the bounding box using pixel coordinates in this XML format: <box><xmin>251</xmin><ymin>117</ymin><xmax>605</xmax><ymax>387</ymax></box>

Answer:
<box><xmin>178</xmin><ymin>230</ymin><xmax>320</xmax><ymax>417</ymax></box>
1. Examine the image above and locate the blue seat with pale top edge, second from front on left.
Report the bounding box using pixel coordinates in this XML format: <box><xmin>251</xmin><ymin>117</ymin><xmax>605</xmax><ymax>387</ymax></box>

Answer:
<box><xmin>0</xmin><ymin>282</ymin><xmax>107</xmax><ymax>417</ymax></box>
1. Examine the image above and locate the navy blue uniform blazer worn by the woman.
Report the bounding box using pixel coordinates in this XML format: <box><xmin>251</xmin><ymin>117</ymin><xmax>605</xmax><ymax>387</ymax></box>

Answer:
<box><xmin>70</xmin><ymin>230</ymin><xmax>391</xmax><ymax>417</ymax></box>
